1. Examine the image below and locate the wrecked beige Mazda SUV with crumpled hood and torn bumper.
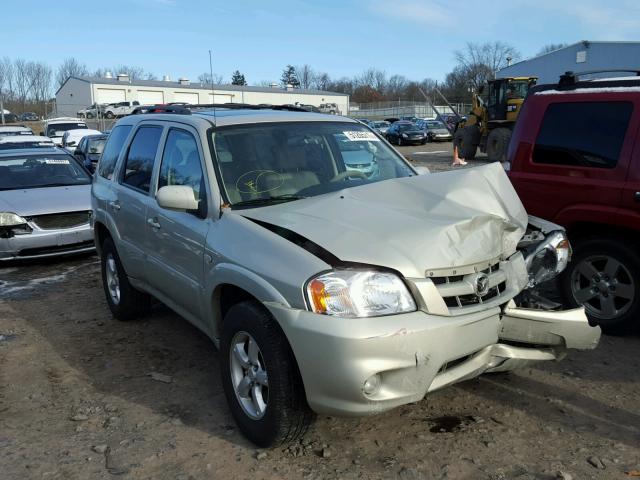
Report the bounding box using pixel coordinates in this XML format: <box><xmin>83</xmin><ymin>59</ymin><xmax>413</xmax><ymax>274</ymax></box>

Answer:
<box><xmin>92</xmin><ymin>106</ymin><xmax>600</xmax><ymax>446</ymax></box>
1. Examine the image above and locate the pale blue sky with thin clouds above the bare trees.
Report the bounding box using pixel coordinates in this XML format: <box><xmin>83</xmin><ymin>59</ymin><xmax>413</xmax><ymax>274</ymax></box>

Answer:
<box><xmin>0</xmin><ymin>0</ymin><xmax>640</xmax><ymax>84</ymax></box>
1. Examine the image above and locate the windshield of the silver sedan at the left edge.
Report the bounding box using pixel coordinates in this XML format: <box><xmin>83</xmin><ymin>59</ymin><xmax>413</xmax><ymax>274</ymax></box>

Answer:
<box><xmin>0</xmin><ymin>154</ymin><xmax>91</xmax><ymax>190</ymax></box>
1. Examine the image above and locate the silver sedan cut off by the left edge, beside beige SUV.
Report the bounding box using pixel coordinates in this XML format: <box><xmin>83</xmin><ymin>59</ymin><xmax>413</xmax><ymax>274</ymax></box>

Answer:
<box><xmin>0</xmin><ymin>147</ymin><xmax>94</xmax><ymax>263</ymax></box>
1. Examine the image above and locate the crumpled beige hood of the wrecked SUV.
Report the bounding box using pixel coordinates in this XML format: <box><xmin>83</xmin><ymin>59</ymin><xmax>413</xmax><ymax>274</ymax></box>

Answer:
<box><xmin>240</xmin><ymin>163</ymin><xmax>527</xmax><ymax>278</ymax></box>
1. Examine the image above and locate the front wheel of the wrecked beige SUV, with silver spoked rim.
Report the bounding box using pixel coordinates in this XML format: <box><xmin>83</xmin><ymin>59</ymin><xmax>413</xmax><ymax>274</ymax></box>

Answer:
<box><xmin>220</xmin><ymin>301</ymin><xmax>314</xmax><ymax>447</ymax></box>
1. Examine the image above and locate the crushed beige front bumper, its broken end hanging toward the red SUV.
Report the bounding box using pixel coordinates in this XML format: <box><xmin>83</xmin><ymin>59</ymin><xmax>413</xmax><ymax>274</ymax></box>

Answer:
<box><xmin>266</xmin><ymin>302</ymin><xmax>600</xmax><ymax>415</ymax></box>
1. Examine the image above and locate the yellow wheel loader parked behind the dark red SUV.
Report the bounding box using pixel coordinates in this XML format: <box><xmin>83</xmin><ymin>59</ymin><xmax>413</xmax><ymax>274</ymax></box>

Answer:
<box><xmin>453</xmin><ymin>77</ymin><xmax>538</xmax><ymax>162</ymax></box>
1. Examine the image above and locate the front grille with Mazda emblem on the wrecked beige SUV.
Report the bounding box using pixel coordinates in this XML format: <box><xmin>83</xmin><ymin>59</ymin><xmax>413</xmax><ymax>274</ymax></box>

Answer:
<box><xmin>431</xmin><ymin>262</ymin><xmax>507</xmax><ymax>314</ymax></box>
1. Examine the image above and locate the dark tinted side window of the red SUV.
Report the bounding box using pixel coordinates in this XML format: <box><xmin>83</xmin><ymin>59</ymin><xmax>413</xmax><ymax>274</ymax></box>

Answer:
<box><xmin>533</xmin><ymin>102</ymin><xmax>633</xmax><ymax>168</ymax></box>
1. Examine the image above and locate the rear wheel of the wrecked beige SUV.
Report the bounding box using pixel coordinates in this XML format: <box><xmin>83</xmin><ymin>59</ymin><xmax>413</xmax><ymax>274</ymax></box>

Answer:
<box><xmin>100</xmin><ymin>238</ymin><xmax>151</xmax><ymax>321</ymax></box>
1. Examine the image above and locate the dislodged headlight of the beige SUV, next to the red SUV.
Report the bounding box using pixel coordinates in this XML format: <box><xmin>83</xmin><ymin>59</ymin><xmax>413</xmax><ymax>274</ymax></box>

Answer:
<box><xmin>525</xmin><ymin>232</ymin><xmax>571</xmax><ymax>287</ymax></box>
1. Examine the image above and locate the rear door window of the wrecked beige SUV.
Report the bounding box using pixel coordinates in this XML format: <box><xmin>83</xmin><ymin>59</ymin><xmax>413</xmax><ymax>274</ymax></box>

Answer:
<box><xmin>122</xmin><ymin>127</ymin><xmax>162</xmax><ymax>193</ymax></box>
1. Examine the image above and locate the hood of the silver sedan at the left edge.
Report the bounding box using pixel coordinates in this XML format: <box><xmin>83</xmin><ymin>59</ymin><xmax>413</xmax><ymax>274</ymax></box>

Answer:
<box><xmin>0</xmin><ymin>185</ymin><xmax>91</xmax><ymax>217</ymax></box>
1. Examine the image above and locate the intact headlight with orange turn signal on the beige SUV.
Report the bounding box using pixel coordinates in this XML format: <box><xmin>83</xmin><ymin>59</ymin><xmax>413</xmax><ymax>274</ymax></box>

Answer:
<box><xmin>306</xmin><ymin>270</ymin><xmax>416</xmax><ymax>318</ymax></box>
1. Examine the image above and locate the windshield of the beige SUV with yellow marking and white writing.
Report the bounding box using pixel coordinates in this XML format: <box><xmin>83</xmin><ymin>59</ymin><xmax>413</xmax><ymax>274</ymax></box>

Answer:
<box><xmin>213</xmin><ymin>122</ymin><xmax>415</xmax><ymax>206</ymax></box>
